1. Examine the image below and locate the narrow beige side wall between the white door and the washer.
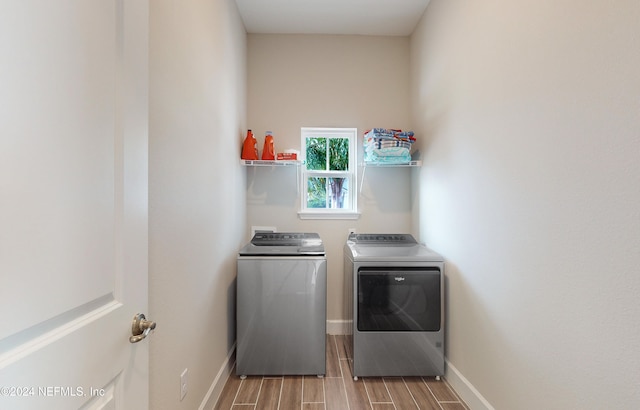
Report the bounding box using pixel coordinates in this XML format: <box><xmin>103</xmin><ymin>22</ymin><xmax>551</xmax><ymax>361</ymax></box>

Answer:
<box><xmin>149</xmin><ymin>0</ymin><xmax>246</xmax><ymax>410</ymax></box>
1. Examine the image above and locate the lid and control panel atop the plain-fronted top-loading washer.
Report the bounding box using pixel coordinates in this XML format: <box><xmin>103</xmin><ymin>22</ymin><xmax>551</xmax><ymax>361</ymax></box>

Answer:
<box><xmin>240</xmin><ymin>232</ymin><xmax>325</xmax><ymax>256</ymax></box>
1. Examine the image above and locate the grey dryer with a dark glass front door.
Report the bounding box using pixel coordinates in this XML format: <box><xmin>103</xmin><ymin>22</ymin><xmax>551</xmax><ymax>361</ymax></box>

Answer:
<box><xmin>344</xmin><ymin>234</ymin><xmax>445</xmax><ymax>380</ymax></box>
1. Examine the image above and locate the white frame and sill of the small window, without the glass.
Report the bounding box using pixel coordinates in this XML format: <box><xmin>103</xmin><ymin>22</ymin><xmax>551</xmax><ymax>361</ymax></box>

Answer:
<box><xmin>298</xmin><ymin>127</ymin><xmax>360</xmax><ymax>219</ymax></box>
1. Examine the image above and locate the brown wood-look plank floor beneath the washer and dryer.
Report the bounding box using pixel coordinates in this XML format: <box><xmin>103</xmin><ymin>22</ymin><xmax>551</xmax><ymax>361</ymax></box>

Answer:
<box><xmin>215</xmin><ymin>335</ymin><xmax>468</xmax><ymax>410</ymax></box>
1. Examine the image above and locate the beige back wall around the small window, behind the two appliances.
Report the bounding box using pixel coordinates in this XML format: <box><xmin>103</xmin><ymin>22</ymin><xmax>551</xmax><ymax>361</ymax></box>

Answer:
<box><xmin>245</xmin><ymin>34</ymin><xmax>412</xmax><ymax>327</ymax></box>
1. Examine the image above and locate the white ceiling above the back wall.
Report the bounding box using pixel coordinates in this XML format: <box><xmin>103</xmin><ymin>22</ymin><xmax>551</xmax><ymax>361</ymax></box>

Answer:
<box><xmin>236</xmin><ymin>0</ymin><xmax>430</xmax><ymax>36</ymax></box>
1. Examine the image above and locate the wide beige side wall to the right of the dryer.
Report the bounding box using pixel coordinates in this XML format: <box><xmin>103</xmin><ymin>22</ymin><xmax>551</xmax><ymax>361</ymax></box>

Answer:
<box><xmin>411</xmin><ymin>0</ymin><xmax>640</xmax><ymax>410</ymax></box>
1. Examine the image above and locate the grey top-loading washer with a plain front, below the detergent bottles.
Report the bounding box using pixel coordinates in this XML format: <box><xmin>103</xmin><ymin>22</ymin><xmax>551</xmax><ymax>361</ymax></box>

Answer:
<box><xmin>236</xmin><ymin>232</ymin><xmax>327</xmax><ymax>378</ymax></box>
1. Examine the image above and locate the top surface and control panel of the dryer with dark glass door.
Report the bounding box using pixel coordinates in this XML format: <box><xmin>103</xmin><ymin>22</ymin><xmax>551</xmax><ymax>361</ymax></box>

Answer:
<box><xmin>345</xmin><ymin>234</ymin><xmax>444</xmax><ymax>262</ymax></box>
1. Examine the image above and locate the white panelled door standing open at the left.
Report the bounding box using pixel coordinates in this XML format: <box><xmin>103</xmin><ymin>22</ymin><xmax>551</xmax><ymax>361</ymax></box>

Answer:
<box><xmin>0</xmin><ymin>0</ymin><xmax>153</xmax><ymax>410</ymax></box>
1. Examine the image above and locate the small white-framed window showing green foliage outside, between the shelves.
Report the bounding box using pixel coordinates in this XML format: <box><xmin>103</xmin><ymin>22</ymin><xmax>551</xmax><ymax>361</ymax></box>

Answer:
<box><xmin>300</xmin><ymin>128</ymin><xmax>358</xmax><ymax>219</ymax></box>
